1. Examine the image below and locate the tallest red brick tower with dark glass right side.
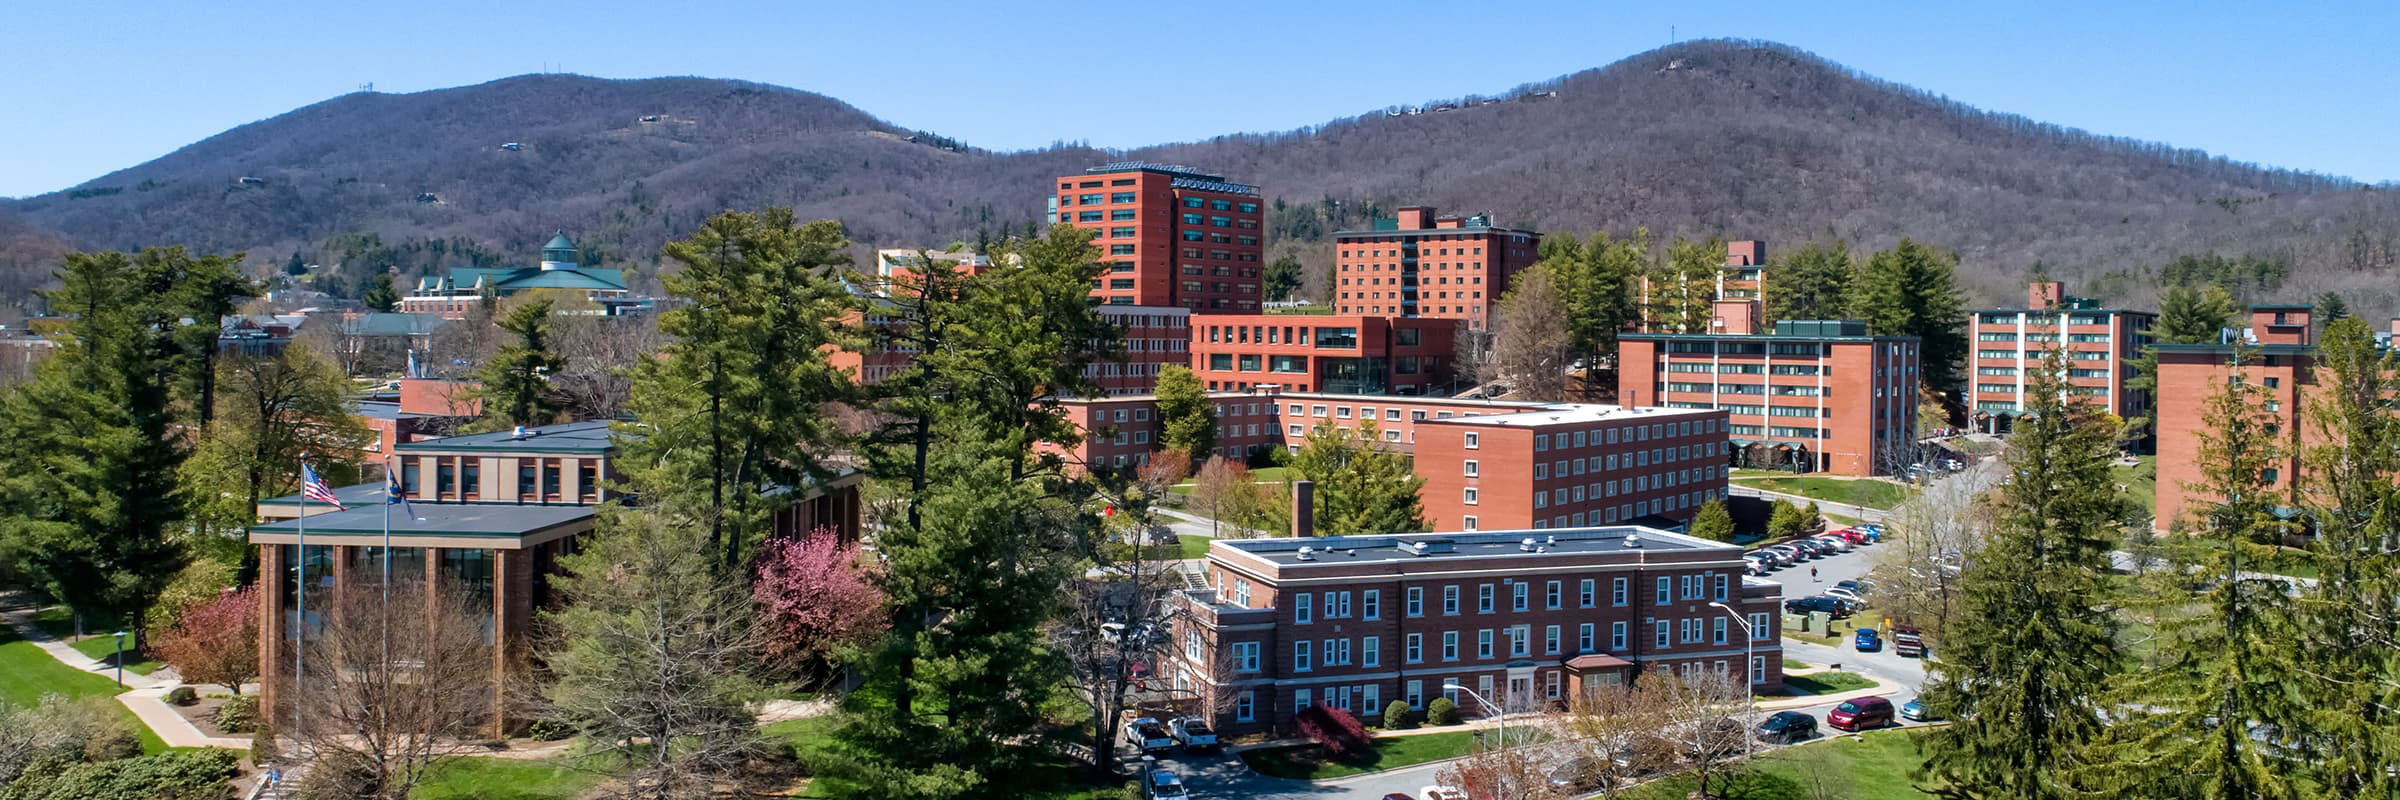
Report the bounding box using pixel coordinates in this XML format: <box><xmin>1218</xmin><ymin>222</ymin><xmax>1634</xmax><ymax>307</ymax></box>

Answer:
<box><xmin>1049</xmin><ymin>161</ymin><xmax>1265</xmax><ymax>315</ymax></box>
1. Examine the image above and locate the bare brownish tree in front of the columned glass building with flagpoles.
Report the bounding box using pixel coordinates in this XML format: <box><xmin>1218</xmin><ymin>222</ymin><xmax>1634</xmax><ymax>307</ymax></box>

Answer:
<box><xmin>290</xmin><ymin>577</ymin><xmax>502</xmax><ymax>800</ymax></box>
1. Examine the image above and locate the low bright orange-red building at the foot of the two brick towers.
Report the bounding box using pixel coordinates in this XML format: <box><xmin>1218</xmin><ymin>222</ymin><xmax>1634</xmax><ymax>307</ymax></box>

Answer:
<box><xmin>1190</xmin><ymin>315</ymin><xmax>1459</xmax><ymax>394</ymax></box>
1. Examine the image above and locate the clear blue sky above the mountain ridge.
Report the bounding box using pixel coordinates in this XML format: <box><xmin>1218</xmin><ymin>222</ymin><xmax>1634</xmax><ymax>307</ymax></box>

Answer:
<box><xmin>0</xmin><ymin>0</ymin><xmax>2400</xmax><ymax>197</ymax></box>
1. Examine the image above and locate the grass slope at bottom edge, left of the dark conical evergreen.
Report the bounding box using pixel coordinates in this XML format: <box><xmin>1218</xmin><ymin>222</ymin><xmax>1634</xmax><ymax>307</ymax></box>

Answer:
<box><xmin>1627</xmin><ymin>730</ymin><xmax>1932</xmax><ymax>800</ymax></box>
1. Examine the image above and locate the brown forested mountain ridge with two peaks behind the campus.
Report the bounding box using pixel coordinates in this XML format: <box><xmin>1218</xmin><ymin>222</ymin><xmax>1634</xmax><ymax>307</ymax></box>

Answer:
<box><xmin>0</xmin><ymin>41</ymin><xmax>2400</xmax><ymax>315</ymax></box>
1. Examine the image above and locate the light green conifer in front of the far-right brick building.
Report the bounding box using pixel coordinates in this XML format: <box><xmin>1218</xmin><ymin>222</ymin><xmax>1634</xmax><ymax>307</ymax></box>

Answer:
<box><xmin>2083</xmin><ymin>344</ymin><xmax>2309</xmax><ymax>800</ymax></box>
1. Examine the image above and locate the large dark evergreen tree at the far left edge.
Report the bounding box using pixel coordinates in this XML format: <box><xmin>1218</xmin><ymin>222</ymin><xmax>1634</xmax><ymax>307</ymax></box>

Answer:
<box><xmin>0</xmin><ymin>247</ymin><xmax>194</xmax><ymax>644</ymax></box>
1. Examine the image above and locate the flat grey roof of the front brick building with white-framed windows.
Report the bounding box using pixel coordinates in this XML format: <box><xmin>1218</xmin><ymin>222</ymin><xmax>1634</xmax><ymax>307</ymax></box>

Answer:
<box><xmin>1212</xmin><ymin>526</ymin><xmax>1742</xmax><ymax>567</ymax></box>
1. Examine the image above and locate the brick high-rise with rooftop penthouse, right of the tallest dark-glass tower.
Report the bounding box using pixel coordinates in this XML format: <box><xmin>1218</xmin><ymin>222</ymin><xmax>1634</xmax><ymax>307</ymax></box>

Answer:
<box><xmin>1334</xmin><ymin>207</ymin><xmax>1541</xmax><ymax>329</ymax></box>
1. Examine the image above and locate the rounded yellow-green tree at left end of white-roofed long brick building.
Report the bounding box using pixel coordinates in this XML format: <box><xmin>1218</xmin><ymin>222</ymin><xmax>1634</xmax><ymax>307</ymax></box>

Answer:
<box><xmin>1291</xmin><ymin>420</ymin><xmax>1426</xmax><ymax>536</ymax></box>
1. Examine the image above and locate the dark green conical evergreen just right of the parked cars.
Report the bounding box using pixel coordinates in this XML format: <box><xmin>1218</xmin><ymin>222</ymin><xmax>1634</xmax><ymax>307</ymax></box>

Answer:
<box><xmin>1925</xmin><ymin>348</ymin><xmax>2124</xmax><ymax>800</ymax></box>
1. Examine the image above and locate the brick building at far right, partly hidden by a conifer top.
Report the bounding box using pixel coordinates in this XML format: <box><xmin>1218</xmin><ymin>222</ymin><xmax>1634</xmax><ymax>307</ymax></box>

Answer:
<box><xmin>2153</xmin><ymin>305</ymin><xmax>2318</xmax><ymax>531</ymax></box>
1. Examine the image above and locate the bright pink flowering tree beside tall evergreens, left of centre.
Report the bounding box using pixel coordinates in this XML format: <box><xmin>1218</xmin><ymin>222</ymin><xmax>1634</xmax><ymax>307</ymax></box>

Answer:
<box><xmin>751</xmin><ymin>529</ymin><xmax>886</xmax><ymax>685</ymax></box>
